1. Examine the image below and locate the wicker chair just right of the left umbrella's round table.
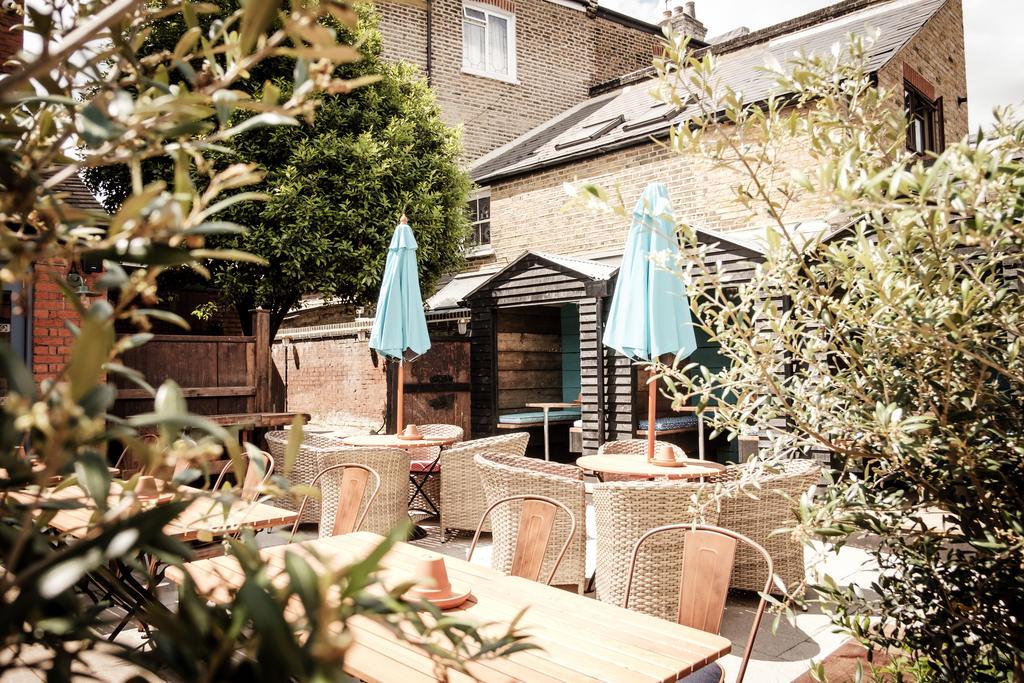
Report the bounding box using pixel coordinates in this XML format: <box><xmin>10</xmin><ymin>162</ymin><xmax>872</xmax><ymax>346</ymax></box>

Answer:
<box><xmin>440</xmin><ymin>432</ymin><xmax>529</xmax><ymax>540</ymax></box>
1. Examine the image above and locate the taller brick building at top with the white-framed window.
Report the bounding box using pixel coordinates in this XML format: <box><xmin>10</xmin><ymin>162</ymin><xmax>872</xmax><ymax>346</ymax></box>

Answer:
<box><xmin>377</xmin><ymin>0</ymin><xmax>662</xmax><ymax>160</ymax></box>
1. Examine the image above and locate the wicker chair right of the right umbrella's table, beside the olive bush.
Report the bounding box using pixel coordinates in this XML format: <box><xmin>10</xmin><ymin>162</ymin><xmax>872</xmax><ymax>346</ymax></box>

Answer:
<box><xmin>716</xmin><ymin>460</ymin><xmax>821</xmax><ymax>591</ymax></box>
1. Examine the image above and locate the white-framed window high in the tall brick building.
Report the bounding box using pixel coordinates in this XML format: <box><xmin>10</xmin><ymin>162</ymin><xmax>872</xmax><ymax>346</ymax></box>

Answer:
<box><xmin>462</xmin><ymin>2</ymin><xmax>516</xmax><ymax>83</ymax></box>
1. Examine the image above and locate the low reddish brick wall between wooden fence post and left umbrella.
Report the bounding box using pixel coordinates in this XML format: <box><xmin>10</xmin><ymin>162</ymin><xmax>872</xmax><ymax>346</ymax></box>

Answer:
<box><xmin>271</xmin><ymin>337</ymin><xmax>387</xmax><ymax>427</ymax></box>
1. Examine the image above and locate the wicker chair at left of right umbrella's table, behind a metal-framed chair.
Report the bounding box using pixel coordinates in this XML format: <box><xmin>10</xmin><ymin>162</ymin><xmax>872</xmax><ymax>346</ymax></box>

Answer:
<box><xmin>474</xmin><ymin>453</ymin><xmax>587</xmax><ymax>593</ymax></box>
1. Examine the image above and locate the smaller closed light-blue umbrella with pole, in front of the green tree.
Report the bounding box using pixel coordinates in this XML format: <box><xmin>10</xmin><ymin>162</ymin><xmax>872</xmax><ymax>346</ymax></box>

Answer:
<box><xmin>370</xmin><ymin>216</ymin><xmax>430</xmax><ymax>432</ymax></box>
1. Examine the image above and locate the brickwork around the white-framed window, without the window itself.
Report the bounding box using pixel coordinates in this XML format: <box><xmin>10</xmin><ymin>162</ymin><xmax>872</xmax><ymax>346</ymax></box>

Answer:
<box><xmin>378</xmin><ymin>0</ymin><xmax>659</xmax><ymax>160</ymax></box>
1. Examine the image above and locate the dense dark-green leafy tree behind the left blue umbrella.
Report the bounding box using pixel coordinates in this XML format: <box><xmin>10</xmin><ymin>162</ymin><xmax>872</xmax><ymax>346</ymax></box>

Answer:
<box><xmin>86</xmin><ymin>0</ymin><xmax>470</xmax><ymax>336</ymax></box>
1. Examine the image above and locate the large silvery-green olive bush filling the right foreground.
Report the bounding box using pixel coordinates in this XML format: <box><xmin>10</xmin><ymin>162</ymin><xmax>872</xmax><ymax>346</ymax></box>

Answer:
<box><xmin>583</xmin><ymin>33</ymin><xmax>1024</xmax><ymax>681</ymax></box>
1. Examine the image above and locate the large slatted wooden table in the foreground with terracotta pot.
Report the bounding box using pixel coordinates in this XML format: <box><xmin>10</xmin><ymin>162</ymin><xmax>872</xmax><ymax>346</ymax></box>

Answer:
<box><xmin>167</xmin><ymin>532</ymin><xmax>732</xmax><ymax>683</ymax></box>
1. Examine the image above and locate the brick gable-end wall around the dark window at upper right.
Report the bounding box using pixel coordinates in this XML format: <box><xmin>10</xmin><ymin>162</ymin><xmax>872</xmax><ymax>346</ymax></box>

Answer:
<box><xmin>879</xmin><ymin>0</ymin><xmax>969</xmax><ymax>144</ymax></box>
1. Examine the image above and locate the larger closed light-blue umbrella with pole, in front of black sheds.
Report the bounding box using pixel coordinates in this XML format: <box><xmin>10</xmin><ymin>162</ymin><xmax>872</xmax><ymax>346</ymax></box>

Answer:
<box><xmin>603</xmin><ymin>182</ymin><xmax>697</xmax><ymax>460</ymax></box>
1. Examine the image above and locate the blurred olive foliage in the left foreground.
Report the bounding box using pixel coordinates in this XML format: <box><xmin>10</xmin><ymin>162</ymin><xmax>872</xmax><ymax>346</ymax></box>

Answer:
<box><xmin>0</xmin><ymin>0</ymin><xmax>520</xmax><ymax>681</ymax></box>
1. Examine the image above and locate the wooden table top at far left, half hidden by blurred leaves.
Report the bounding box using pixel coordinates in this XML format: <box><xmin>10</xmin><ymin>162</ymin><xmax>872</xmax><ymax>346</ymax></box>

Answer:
<box><xmin>10</xmin><ymin>483</ymin><xmax>298</xmax><ymax>542</ymax></box>
